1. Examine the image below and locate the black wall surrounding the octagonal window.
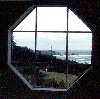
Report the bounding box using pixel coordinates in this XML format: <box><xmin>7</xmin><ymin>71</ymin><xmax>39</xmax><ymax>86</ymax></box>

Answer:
<box><xmin>0</xmin><ymin>0</ymin><xmax>100</xmax><ymax>99</ymax></box>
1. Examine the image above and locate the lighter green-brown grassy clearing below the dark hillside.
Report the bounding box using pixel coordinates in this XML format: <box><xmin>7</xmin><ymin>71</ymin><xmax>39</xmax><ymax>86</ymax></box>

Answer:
<box><xmin>40</xmin><ymin>71</ymin><xmax>78</xmax><ymax>87</ymax></box>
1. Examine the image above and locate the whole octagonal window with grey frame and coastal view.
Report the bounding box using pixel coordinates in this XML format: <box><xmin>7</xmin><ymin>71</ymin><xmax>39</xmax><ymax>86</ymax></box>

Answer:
<box><xmin>8</xmin><ymin>7</ymin><xmax>92</xmax><ymax>91</ymax></box>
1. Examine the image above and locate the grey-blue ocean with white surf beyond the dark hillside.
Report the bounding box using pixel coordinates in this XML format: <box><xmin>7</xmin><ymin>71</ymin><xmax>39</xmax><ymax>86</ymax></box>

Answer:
<box><xmin>53</xmin><ymin>50</ymin><xmax>91</xmax><ymax>64</ymax></box>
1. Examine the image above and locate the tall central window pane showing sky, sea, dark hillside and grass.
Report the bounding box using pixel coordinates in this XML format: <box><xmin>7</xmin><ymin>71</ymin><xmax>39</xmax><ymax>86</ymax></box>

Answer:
<box><xmin>37</xmin><ymin>32</ymin><xmax>66</xmax><ymax>88</ymax></box>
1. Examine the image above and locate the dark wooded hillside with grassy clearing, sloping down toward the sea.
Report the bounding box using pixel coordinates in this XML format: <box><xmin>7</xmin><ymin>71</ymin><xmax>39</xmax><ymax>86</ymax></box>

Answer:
<box><xmin>12</xmin><ymin>42</ymin><xmax>89</xmax><ymax>88</ymax></box>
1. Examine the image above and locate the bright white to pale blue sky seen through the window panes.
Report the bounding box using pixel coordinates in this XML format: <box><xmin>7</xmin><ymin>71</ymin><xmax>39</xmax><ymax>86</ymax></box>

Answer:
<box><xmin>13</xmin><ymin>7</ymin><xmax>92</xmax><ymax>50</ymax></box>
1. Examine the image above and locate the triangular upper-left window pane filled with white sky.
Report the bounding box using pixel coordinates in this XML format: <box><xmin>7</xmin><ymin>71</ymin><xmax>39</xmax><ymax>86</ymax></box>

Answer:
<box><xmin>14</xmin><ymin>9</ymin><xmax>36</xmax><ymax>31</ymax></box>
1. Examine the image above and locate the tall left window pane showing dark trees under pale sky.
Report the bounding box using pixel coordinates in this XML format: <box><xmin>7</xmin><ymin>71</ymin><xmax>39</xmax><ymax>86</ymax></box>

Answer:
<box><xmin>11</xmin><ymin>32</ymin><xmax>36</xmax><ymax>84</ymax></box>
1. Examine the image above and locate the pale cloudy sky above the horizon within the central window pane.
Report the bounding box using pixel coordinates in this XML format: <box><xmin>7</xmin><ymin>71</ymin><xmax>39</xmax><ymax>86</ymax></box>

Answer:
<box><xmin>37</xmin><ymin>32</ymin><xmax>66</xmax><ymax>51</ymax></box>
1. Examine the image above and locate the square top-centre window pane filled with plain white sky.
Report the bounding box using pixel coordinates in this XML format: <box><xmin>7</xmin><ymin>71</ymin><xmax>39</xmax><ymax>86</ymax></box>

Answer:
<box><xmin>37</xmin><ymin>7</ymin><xmax>67</xmax><ymax>31</ymax></box>
